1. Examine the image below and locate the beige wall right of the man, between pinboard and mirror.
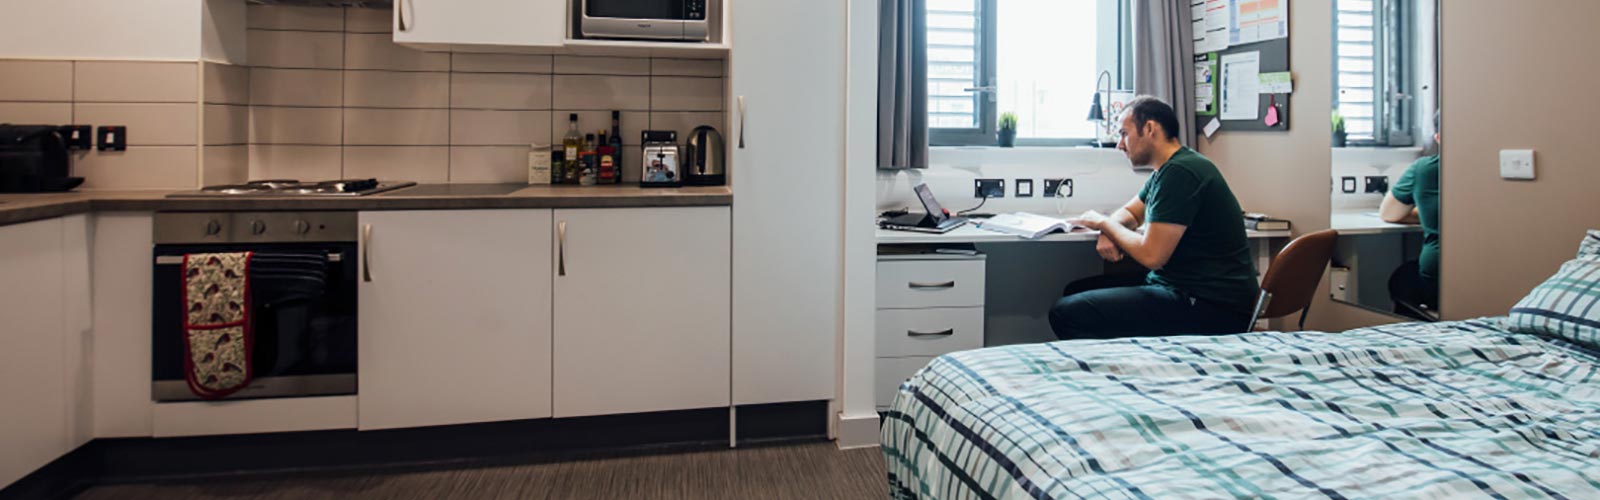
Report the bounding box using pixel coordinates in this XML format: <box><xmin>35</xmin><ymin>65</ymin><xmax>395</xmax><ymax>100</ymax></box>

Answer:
<box><xmin>1198</xmin><ymin>0</ymin><xmax>1395</xmax><ymax>332</ymax></box>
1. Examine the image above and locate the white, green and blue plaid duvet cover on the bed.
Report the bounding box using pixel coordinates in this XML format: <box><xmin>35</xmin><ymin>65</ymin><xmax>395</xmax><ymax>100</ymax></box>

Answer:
<box><xmin>880</xmin><ymin>319</ymin><xmax>1600</xmax><ymax>500</ymax></box>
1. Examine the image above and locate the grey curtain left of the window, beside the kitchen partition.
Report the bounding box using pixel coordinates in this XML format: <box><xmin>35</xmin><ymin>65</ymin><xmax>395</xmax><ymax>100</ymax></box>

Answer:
<box><xmin>877</xmin><ymin>0</ymin><xmax>928</xmax><ymax>168</ymax></box>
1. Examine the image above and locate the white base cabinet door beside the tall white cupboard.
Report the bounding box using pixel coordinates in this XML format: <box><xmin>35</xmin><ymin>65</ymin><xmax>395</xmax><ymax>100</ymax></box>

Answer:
<box><xmin>550</xmin><ymin>207</ymin><xmax>731</xmax><ymax>417</ymax></box>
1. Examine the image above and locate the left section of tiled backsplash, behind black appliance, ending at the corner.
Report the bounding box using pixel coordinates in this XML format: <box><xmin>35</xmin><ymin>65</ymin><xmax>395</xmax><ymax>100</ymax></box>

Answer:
<box><xmin>0</xmin><ymin>61</ymin><xmax>200</xmax><ymax>189</ymax></box>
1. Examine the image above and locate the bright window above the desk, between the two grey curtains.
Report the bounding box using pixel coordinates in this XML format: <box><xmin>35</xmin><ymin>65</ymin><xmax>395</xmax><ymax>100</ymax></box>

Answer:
<box><xmin>928</xmin><ymin>0</ymin><xmax>1133</xmax><ymax>146</ymax></box>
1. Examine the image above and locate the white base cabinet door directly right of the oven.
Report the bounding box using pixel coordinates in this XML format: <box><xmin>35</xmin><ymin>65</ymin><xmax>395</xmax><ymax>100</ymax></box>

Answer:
<box><xmin>358</xmin><ymin>209</ymin><xmax>550</xmax><ymax>429</ymax></box>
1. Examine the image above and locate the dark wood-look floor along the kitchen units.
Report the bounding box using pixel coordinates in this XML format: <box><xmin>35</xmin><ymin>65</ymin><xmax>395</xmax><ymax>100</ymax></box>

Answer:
<box><xmin>77</xmin><ymin>442</ymin><xmax>888</xmax><ymax>500</ymax></box>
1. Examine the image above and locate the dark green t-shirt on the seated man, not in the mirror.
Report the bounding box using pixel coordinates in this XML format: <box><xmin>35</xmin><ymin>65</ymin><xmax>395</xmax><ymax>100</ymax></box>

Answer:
<box><xmin>1139</xmin><ymin>147</ymin><xmax>1261</xmax><ymax>314</ymax></box>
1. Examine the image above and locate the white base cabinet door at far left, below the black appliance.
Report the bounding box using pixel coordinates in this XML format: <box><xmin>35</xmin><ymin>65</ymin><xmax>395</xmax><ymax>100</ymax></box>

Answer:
<box><xmin>0</xmin><ymin>220</ymin><xmax>70</xmax><ymax>487</ymax></box>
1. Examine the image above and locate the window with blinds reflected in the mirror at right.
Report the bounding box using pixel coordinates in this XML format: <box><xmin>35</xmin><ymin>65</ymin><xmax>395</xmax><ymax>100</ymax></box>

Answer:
<box><xmin>1333</xmin><ymin>0</ymin><xmax>1418</xmax><ymax>146</ymax></box>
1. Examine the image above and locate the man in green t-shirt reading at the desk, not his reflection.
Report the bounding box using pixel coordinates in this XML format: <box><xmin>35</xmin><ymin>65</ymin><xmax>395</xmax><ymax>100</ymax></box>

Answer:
<box><xmin>1050</xmin><ymin>96</ymin><xmax>1259</xmax><ymax>340</ymax></box>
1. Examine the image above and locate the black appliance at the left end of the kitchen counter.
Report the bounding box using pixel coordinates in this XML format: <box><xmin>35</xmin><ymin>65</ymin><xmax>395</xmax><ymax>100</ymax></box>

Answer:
<box><xmin>0</xmin><ymin>125</ymin><xmax>83</xmax><ymax>192</ymax></box>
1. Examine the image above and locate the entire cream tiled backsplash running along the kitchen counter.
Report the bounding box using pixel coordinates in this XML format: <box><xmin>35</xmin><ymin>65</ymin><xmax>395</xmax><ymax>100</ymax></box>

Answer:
<box><xmin>0</xmin><ymin>5</ymin><xmax>726</xmax><ymax>189</ymax></box>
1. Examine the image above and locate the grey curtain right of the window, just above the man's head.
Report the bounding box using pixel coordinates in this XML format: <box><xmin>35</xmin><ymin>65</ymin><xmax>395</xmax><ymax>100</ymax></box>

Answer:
<box><xmin>1133</xmin><ymin>0</ymin><xmax>1195</xmax><ymax>146</ymax></box>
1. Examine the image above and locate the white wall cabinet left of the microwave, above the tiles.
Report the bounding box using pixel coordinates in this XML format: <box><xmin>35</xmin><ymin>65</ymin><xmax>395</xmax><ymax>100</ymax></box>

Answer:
<box><xmin>394</xmin><ymin>0</ymin><xmax>571</xmax><ymax>50</ymax></box>
